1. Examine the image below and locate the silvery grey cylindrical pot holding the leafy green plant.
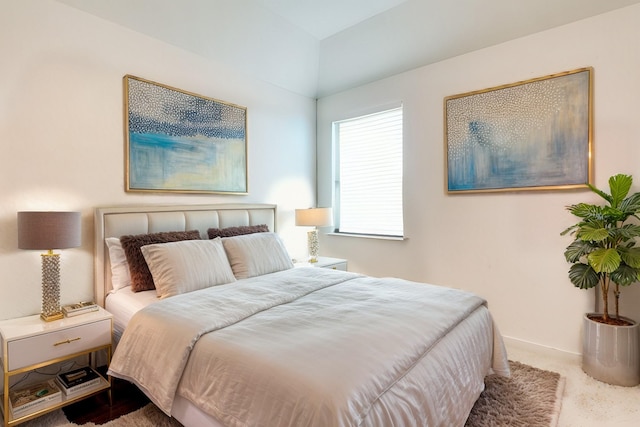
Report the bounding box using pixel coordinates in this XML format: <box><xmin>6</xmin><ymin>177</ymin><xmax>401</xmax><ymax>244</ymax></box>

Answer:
<box><xmin>582</xmin><ymin>313</ymin><xmax>640</xmax><ymax>387</ymax></box>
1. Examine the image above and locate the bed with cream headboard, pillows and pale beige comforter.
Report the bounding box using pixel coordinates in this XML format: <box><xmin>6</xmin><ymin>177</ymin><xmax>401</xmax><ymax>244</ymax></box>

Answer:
<box><xmin>95</xmin><ymin>204</ymin><xmax>509</xmax><ymax>427</ymax></box>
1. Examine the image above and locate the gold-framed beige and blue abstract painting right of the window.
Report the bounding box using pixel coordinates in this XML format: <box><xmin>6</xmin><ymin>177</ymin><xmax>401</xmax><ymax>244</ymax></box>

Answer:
<box><xmin>444</xmin><ymin>68</ymin><xmax>593</xmax><ymax>194</ymax></box>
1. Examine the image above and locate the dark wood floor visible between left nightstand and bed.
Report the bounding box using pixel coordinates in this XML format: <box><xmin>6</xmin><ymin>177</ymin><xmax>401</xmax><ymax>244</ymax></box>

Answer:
<box><xmin>63</xmin><ymin>378</ymin><xmax>149</xmax><ymax>425</ymax></box>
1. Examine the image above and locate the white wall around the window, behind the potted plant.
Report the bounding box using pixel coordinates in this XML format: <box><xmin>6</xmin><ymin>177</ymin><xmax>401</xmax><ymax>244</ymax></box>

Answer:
<box><xmin>317</xmin><ymin>6</ymin><xmax>640</xmax><ymax>353</ymax></box>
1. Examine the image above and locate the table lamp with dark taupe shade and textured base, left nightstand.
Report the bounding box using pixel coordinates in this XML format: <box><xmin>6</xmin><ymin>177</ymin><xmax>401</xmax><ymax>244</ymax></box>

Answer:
<box><xmin>18</xmin><ymin>212</ymin><xmax>81</xmax><ymax>322</ymax></box>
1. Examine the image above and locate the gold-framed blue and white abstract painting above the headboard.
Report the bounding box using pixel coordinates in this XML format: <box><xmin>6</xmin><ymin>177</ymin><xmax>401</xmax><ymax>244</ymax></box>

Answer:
<box><xmin>124</xmin><ymin>76</ymin><xmax>247</xmax><ymax>194</ymax></box>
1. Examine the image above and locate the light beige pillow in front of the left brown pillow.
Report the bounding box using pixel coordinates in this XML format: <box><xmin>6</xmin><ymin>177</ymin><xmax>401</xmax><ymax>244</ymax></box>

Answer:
<box><xmin>140</xmin><ymin>238</ymin><xmax>236</xmax><ymax>298</ymax></box>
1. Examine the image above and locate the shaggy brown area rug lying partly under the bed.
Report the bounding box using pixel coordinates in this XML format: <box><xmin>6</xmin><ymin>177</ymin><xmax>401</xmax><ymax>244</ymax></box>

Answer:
<box><xmin>21</xmin><ymin>362</ymin><xmax>564</xmax><ymax>427</ymax></box>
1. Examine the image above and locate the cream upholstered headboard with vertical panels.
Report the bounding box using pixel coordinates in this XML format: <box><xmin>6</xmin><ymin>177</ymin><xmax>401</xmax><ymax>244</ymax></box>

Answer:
<box><xmin>94</xmin><ymin>204</ymin><xmax>276</xmax><ymax>307</ymax></box>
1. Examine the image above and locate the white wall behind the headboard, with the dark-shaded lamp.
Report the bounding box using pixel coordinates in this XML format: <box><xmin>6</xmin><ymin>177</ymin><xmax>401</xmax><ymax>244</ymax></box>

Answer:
<box><xmin>0</xmin><ymin>0</ymin><xmax>315</xmax><ymax>319</ymax></box>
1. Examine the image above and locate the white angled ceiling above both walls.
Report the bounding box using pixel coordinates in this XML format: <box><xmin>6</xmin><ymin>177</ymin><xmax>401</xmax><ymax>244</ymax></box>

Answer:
<box><xmin>56</xmin><ymin>0</ymin><xmax>640</xmax><ymax>98</ymax></box>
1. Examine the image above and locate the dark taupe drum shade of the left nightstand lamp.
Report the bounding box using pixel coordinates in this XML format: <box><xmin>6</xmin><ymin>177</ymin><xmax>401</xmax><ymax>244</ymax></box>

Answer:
<box><xmin>18</xmin><ymin>212</ymin><xmax>81</xmax><ymax>250</ymax></box>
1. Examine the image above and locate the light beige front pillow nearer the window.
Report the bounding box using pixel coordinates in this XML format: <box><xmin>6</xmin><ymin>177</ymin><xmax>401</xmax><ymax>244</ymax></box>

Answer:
<box><xmin>222</xmin><ymin>233</ymin><xmax>293</xmax><ymax>279</ymax></box>
